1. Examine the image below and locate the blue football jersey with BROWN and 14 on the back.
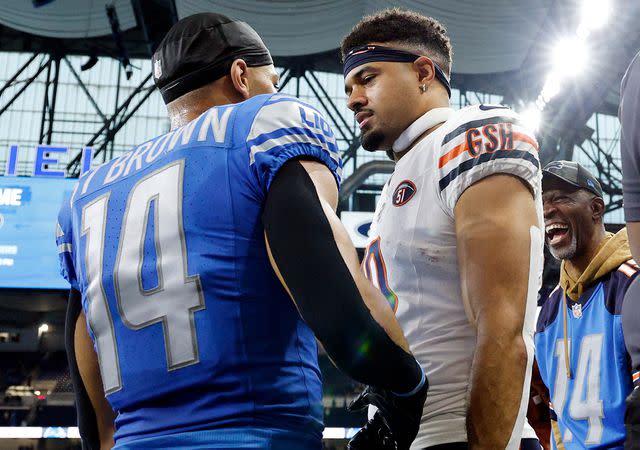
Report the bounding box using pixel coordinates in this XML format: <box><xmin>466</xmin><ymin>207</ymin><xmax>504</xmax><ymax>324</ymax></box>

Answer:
<box><xmin>57</xmin><ymin>94</ymin><xmax>341</xmax><ymax>448</ymax></box>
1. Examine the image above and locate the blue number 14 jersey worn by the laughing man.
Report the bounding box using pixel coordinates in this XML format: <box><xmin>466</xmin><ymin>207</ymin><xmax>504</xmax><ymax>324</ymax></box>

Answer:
<box><xmin>535</xmin><ymin>262</ymin><xmax>638</xmax><ymax>450</ymax></box>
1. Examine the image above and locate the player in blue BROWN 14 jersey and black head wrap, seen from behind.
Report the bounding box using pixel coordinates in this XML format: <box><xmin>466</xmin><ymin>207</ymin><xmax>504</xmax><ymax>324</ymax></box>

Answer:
<box><xmin>57</xmin><ymin>14</ymin><xmax>428</xmax><ymax>450</ymax></box>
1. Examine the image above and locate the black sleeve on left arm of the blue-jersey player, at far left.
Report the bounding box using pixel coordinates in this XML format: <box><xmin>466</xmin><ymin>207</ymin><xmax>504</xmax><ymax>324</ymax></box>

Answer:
<box><xmin>64</xmin><ymin>288</ymin><xmax>100</xmax><ymax>450</ymax></box>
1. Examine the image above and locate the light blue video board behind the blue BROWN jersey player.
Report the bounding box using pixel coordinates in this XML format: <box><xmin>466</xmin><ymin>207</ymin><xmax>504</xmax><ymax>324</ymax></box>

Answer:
<box><xmin>0</xmin><ymin>176</ymin><xmax>77</xmax><ymax>289</ymax></box>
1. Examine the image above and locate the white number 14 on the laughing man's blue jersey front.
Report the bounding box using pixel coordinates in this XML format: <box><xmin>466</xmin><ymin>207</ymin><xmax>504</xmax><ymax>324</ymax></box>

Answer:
<box><xmin>552</xmin><ymin>333</ymin><xmax>604</xmax><ymax>444</ymax></box>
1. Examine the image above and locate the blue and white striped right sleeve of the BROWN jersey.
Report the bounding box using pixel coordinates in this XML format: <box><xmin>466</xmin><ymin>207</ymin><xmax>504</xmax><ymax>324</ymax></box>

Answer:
<box><xmin>246</xmin><ymin>95</ymin><xmax>342</xmax><ymax>193</ymax></box>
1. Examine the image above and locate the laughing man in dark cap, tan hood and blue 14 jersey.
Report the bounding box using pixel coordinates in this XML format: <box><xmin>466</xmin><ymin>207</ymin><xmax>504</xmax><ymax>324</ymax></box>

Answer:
<box><xmin>535</xmin><ymin>161</ymin><xmax>638</xmax><ymax>449</ymax></box>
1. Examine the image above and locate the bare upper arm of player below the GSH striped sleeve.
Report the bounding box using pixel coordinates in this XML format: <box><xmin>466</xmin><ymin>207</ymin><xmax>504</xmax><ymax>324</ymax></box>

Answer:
<box><xmin>454</xmin><ymin>175</ymin><xmax>542</xmax><ymax>330</ymax></box>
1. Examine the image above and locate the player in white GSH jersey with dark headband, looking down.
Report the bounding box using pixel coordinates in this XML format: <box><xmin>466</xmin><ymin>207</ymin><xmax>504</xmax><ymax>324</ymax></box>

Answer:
<box><xmin>341</xmin><ymin>9</ymin><xmax>543</xmax><ymax>450</ymax></box>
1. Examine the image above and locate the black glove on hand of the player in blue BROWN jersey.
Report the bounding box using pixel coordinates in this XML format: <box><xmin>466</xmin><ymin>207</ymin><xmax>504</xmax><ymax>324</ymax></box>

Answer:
<box><xmin>347</xmin><ymin>377</ymin><xmax>429</xmax><ymax>450</ymax></box>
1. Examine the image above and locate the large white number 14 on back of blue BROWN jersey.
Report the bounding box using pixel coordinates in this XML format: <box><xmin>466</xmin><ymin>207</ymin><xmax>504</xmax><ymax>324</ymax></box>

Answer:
<box><xmin>81</xmin><ymin>160</ymin><xmax>205</xmax><ymax>394</ymax></box>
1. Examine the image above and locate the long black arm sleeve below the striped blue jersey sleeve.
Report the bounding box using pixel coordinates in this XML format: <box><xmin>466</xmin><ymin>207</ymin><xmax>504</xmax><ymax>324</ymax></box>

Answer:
<box><xmin>262</xmin><ymin>160</ymin><xmax>423</xmax><ymax>393</ymax></box>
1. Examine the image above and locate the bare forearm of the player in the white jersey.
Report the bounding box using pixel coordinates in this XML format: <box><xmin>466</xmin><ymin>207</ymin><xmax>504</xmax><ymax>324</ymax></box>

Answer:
<box><xmin>467</xmin><ymin>330</ymin><xmax>528</xmax><ymax>449</ymax></box>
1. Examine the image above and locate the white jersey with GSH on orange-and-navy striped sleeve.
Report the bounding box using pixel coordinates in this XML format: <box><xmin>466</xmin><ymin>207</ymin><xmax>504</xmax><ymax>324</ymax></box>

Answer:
<box><xmin>363</xmin><ymin>105</ymin><xmax>543</xmax><ymax>449</ymax></box>
